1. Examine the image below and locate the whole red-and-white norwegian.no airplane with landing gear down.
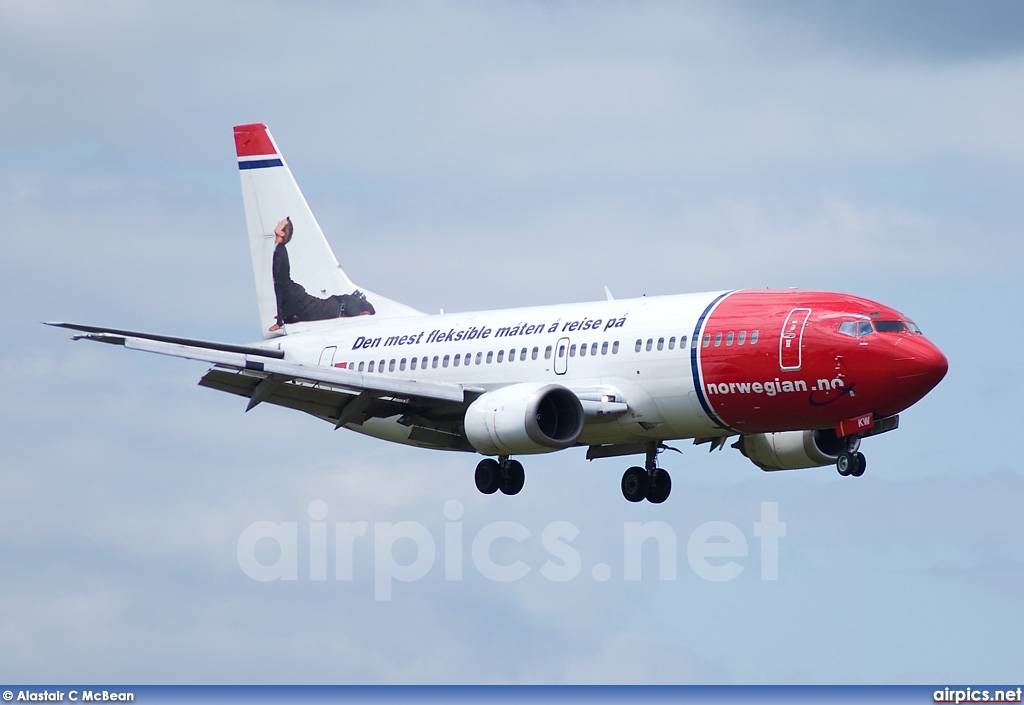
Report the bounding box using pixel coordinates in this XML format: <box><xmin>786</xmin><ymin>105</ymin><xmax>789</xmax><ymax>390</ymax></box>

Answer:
<box><xmin>47</xmin><ymin>124</ymin><xmax>948</xmax><ymax>504</ymax></box>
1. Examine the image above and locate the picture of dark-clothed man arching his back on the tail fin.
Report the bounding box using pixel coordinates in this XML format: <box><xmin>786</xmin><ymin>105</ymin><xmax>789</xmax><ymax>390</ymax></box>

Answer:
<box><xmin>269</xmin><ymin>217</ymin><xmax>377</xmax><ymax>331</ymax></box>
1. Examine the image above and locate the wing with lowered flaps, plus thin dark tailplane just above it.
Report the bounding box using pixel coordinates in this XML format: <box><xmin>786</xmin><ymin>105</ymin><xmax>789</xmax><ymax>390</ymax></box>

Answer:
<box><xmin>46</xmin><ymin>323</ymin><xmax>484</xmax><ymax>449</ymax></box>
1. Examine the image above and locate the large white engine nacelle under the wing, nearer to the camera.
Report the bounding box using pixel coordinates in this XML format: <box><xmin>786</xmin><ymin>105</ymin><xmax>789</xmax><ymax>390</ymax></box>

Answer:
<box><xmin>465</xmin><ymin>382</ymin><xmax>584</xmax><ymax>455</ymax></box>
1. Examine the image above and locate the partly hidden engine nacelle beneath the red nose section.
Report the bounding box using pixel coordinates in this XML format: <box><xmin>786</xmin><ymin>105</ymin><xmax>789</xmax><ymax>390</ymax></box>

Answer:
<box><xmin>733</xmin><ymin>429</ymin><xmax>860</xmax><ymax>470</ymax></box>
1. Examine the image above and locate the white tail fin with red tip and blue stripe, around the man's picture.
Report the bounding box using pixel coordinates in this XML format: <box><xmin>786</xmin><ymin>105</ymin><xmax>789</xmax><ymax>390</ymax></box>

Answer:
<box><xmin>234</xmin><ymin>124</ymin><xmax>423</xmax><ymax>338</ymax></box>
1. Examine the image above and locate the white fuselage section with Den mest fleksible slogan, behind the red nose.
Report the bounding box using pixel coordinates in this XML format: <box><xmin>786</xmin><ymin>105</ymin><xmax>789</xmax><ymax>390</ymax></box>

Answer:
<box><xmin>262</xmin><ymin>292</ymin><xmax>724</xmax><ymax>445</ymax></box>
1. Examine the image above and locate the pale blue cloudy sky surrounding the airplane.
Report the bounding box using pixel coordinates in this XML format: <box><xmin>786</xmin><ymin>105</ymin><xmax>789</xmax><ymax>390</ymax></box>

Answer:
<box><xmin>0</xmin><ymin>0</ymin><xmax>1024</xmax><ymax>685</ymax></box>
